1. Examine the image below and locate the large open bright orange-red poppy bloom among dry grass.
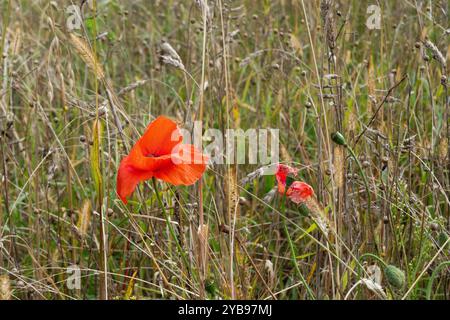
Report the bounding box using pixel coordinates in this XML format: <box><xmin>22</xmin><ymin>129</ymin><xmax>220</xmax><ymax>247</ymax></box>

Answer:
<box><xmin>117</xmin><ymin>116</ymin><xmax>207</xmax><ymax>204</ymax></box>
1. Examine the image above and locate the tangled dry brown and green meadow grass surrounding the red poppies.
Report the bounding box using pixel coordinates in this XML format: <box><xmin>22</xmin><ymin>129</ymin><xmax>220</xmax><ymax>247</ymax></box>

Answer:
<box><xmin>0</xmin><ymin>0</ymin><xmax>450</xmax><ymax>300</ymax></box>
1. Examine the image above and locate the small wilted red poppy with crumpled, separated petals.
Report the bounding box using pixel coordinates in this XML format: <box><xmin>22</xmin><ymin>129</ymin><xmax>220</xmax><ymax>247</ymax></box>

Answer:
<box><xmin>275</xmin><ymin>164</ymin><xmax>314</xmax><ymax>204</ymax></box>
